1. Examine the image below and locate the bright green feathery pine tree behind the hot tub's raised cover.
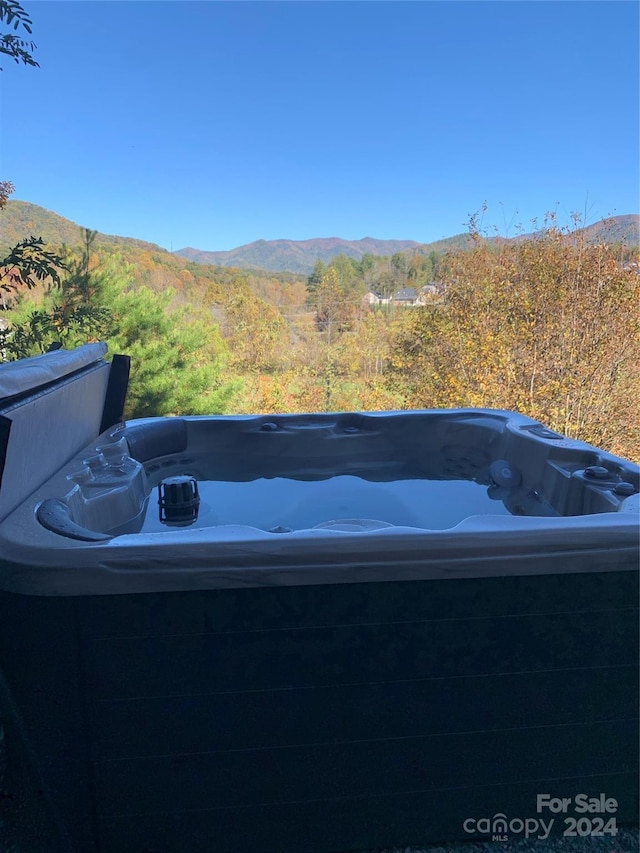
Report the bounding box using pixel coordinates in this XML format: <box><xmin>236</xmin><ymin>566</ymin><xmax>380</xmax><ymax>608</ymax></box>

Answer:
<box><xmin>0</xmin><ymin>235</ymin><xmax>237</xmax><ymax>417</ymax></box>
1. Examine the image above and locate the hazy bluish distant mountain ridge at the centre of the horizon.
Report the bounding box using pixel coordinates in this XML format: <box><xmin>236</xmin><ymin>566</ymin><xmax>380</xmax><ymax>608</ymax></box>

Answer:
<box><xmin>174</xmin><ymin>237</ymin><xmax>420</xmax><ymax>273</ymax></box>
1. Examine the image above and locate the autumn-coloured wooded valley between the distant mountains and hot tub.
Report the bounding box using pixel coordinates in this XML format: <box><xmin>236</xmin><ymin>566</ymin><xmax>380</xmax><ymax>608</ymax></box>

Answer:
<box><xmin>0</xmin><ymin>202</ymin><xmax>640</xmax><ymax>459</ymax></box>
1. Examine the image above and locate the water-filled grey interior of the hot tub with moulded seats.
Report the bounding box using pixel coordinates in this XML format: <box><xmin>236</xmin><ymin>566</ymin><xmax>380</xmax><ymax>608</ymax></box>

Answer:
<box><xmin>39</xmin><ymin>410</ymin><xmax>637</xmax><ymax>536</ymax></box>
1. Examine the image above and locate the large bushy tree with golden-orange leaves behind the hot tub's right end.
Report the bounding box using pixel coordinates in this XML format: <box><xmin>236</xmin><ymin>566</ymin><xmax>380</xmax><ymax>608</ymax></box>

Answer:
<box><xmin>392</xmin><ymin>220</ymin><xmax>640</xmax><ymax>456</ymax></box>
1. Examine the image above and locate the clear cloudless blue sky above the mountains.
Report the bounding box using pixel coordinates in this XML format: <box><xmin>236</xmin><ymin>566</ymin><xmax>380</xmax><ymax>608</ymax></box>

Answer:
<box><xmin>0</xmin><ymin>0</ymin><xmax>640</xmax><ymax>250</ymax></box>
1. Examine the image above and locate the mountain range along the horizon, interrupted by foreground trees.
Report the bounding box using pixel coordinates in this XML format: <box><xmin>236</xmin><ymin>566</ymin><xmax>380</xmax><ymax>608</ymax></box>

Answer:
<box><xmin>0</xmin><ymin>200</ymin><xmax>640</xmax><ymax>275</ymax></box>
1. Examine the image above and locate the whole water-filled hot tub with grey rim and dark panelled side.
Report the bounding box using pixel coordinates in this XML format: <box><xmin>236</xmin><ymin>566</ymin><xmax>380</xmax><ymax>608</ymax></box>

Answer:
<box><xmin>0</xmin><ymin>346</ymin><xmax>640</xmax><ymax>853</ymax></box>
